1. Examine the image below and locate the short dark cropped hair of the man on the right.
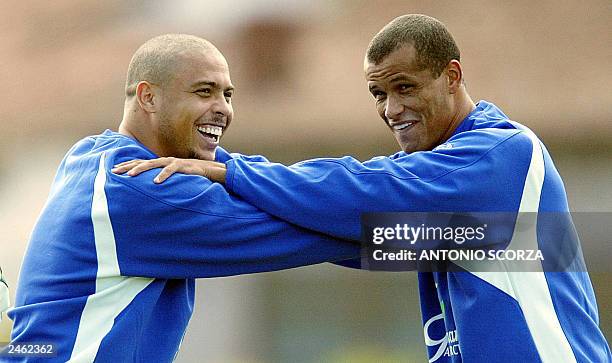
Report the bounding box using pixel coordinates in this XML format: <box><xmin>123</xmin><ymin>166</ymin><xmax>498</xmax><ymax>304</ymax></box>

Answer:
<box><xmin>366</xmin><ymin>14</ymin><xmax>460</xmax><ymax>78</ymax></box>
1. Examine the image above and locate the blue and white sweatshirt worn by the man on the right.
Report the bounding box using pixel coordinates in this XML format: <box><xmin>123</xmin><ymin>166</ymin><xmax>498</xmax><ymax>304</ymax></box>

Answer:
<box><xmin>226</xmin><ymin>101</ymin><xmax>612</xmax><ymax>363</ymax></box>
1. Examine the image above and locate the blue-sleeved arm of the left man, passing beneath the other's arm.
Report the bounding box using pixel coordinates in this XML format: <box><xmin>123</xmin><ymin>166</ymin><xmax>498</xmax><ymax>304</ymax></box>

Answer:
<box><xmin>104</xmin><ymin>146</ymin><xmax>360</xmax><ymax>278</ymax></box>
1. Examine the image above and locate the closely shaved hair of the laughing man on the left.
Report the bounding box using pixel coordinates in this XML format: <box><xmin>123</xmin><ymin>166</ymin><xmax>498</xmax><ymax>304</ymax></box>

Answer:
<box><xmin>125</xmin><ymin>34</ymin><xmax>216</xmax><ymax>97</ymax></box>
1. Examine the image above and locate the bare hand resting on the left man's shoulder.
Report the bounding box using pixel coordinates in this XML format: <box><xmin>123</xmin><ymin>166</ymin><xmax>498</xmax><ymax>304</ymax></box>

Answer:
<box><xmin>111</xmin><ymin>157</ymin><xmax>227</xmax><ymax>184</ymax></box>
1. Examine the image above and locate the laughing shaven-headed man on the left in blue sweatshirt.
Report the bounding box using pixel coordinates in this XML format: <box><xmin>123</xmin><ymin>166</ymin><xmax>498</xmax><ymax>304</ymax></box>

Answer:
<box><xmin>0</xmin><ymin>34</ymin><xmax>359</xmax><ymax>362</ymax></box>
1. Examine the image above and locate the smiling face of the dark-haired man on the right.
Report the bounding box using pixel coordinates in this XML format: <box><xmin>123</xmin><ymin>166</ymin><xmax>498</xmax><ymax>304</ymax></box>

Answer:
<box><xmin>364</xmin><ymin>34</ymin><xmax>475</xmax><ymax>153</ymax></box>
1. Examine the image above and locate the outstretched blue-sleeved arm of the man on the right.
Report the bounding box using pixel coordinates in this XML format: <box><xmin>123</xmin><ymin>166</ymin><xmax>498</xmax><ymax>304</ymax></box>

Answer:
<box><xmin>112</xmin><ymin>129</ymin><xmax>532</xmax><ymax>240</ymax></box>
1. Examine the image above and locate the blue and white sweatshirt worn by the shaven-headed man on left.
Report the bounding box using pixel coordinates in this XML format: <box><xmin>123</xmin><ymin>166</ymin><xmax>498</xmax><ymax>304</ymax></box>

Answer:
<box><xmin>0</xmin><ymin>130</ymin><xmax>360</xmax><ymax>362</ymax></box>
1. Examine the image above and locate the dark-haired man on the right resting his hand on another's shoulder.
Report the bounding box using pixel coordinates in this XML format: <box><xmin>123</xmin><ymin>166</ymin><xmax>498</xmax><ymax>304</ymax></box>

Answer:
<box><xmin>116</xmin><ymin>15</ymin><xmax>611</xmax><ymax>363</ymax></box>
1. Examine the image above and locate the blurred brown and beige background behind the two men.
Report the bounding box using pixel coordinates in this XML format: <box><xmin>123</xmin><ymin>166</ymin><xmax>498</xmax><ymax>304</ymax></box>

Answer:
<box><xmin>0</xmin><ymin>0</ymin><xmax>612</xmax><ymax>362</ymax></box>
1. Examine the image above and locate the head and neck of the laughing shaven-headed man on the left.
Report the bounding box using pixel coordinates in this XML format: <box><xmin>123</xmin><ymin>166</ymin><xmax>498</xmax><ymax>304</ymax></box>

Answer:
<box><xmin>119</xmin><ymin>36</ymin><xmax>234</xmax><ymax>160</ymax></box>
